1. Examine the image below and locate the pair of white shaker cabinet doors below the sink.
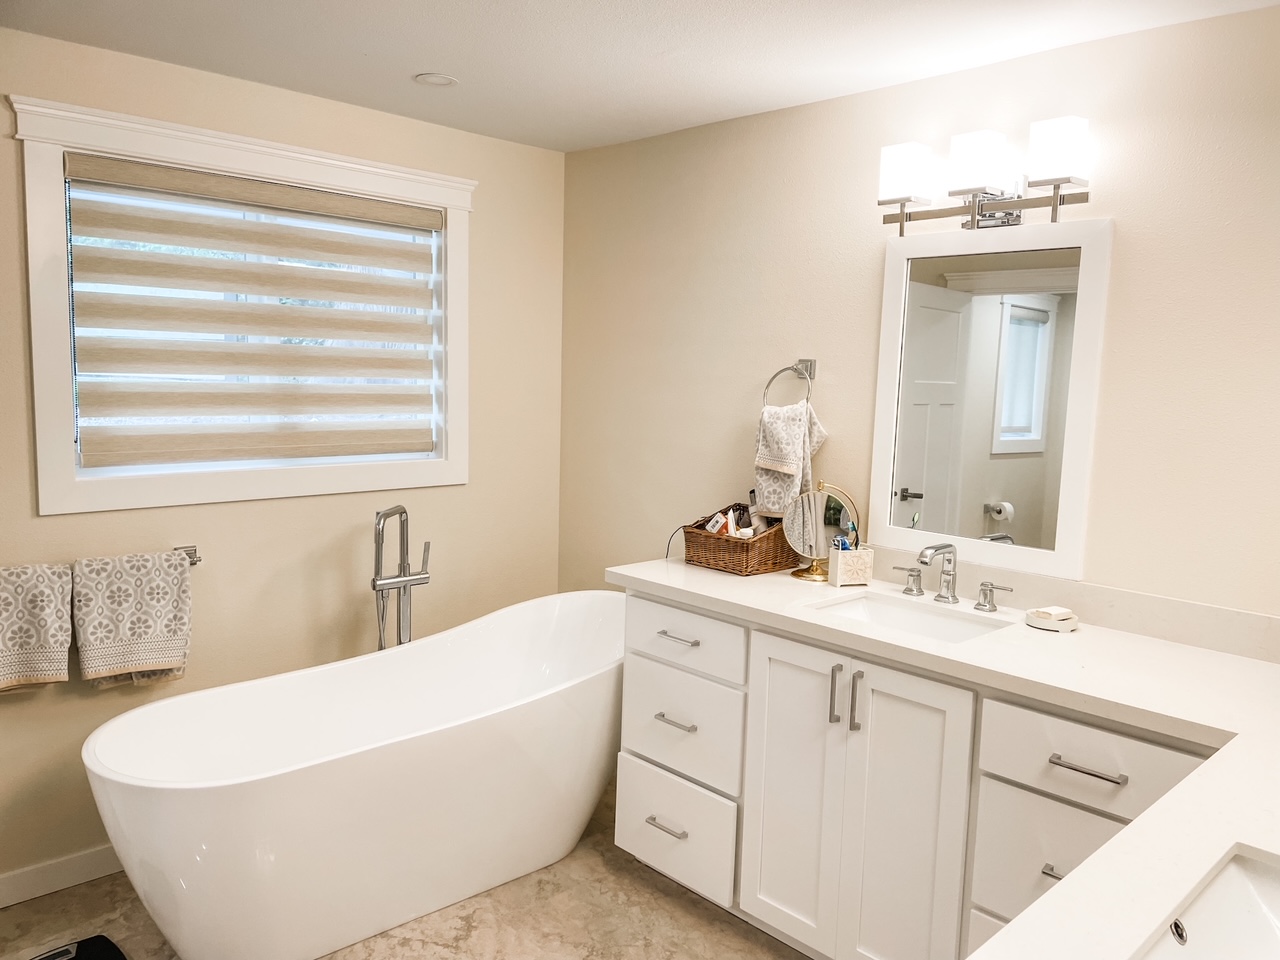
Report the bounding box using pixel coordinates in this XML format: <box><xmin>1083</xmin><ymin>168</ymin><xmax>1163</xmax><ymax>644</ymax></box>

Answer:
<box><xmin>739</xmin><ymin>631</ymin><xmax>974</xmax><ymax>960</ymax></box>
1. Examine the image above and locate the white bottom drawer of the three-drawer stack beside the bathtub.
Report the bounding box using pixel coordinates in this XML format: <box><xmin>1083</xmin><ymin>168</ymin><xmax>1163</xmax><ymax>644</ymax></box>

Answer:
<box><xmin>613</xmin><ymin>754</ymin><xmax>737</xmax><ymax>906</ymax></box>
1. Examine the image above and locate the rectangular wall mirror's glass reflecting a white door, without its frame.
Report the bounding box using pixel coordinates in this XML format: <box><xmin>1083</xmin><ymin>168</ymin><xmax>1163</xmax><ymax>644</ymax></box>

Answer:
<box><xmin>890</xmin><ymin>247</ymin><xmax>1080</xmax><ymax>549</ymax></box>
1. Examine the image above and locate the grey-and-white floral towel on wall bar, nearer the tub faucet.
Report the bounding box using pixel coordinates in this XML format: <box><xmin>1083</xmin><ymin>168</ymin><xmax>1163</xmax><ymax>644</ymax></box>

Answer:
<box><xmin>72</xmin><ymin>550</ymin><xmax>191</xmax><ymax>687</ymax></box>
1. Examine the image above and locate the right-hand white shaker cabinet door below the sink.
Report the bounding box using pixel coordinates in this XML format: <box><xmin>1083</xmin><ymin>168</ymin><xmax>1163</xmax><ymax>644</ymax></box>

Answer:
<box><xmin>836</xmin><ymin>663</ymin><xmax>974</xmax><ymax>960</ymax></box>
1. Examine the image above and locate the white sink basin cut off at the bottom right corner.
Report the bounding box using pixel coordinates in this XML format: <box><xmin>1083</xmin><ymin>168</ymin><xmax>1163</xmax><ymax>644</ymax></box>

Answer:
<box><xmin>1135</xmin><ymin>854</ymin><xmax>1280</xmax><ymax>960</ymax></box>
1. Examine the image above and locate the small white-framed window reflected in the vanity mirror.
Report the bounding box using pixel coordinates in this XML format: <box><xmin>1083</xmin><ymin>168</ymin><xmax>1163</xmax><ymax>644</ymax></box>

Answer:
<box><xmin>991</xmin><ymin>294</ymin><xmax>1057</xmax><ymax>453</ymax></box>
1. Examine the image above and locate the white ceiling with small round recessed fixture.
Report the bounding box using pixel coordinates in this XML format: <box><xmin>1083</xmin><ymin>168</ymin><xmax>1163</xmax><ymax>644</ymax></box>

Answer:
<box><xmin>0</xmin><ymin>0</ymin><xmax>1280</xmax><ymax>151</ymax></box>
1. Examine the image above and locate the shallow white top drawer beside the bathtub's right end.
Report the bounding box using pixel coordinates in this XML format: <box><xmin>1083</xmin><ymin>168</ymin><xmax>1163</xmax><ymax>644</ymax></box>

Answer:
<box><xmin>627</xmin><ymin>596</ymin><xmax>746</xmax><ymax>684</ymax></box>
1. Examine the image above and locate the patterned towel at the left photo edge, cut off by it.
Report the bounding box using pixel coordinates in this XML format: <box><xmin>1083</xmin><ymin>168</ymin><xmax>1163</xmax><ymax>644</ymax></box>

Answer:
<box><xmin>0</xmin><ymin>563</ymin><xmax>72</xmax><ymax>691</ymax></box>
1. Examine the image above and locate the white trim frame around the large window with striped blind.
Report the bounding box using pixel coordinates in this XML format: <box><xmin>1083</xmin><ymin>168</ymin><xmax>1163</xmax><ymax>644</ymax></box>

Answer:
<box><xmin>9</xmin><ymin>96</ymin><xmax>476</xmax><ymax>516</ymax></box>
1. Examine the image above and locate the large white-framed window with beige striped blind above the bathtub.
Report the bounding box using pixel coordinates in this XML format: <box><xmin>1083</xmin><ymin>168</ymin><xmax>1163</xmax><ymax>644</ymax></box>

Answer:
<box><xmin>13</xmin><ymin>97</ymin><xmax>474</xmax><ymax>513</ymax></box>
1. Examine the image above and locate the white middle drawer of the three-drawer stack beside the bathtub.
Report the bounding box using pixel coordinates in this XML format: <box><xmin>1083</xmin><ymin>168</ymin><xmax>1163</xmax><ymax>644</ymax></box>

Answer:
<box><xmin>622</xmin><ymin>653</ymin><xmax>746</xmax><ymax>796</ymax></box>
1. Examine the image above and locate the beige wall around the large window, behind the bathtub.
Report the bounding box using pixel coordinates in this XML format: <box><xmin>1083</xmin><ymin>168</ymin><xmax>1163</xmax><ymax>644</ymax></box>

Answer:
<box><xmin>0</xmin><ymin>29</ymin><xmax>563</xmax><ymax>874</ymax></box>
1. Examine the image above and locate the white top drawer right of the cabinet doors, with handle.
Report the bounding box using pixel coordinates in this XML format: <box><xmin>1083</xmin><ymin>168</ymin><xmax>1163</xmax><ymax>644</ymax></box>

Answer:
<box><xmin>979</xmin><ymin>700</ymin><xmax>1201</xmax><ymax>820</ymax></box>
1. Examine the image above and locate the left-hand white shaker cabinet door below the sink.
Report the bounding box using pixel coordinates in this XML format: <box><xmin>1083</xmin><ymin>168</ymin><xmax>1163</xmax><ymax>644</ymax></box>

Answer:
<box><xmin>739</xmin><ymin>632</ymin><xmax>852</xmax><ymax>956</ymax></box>
